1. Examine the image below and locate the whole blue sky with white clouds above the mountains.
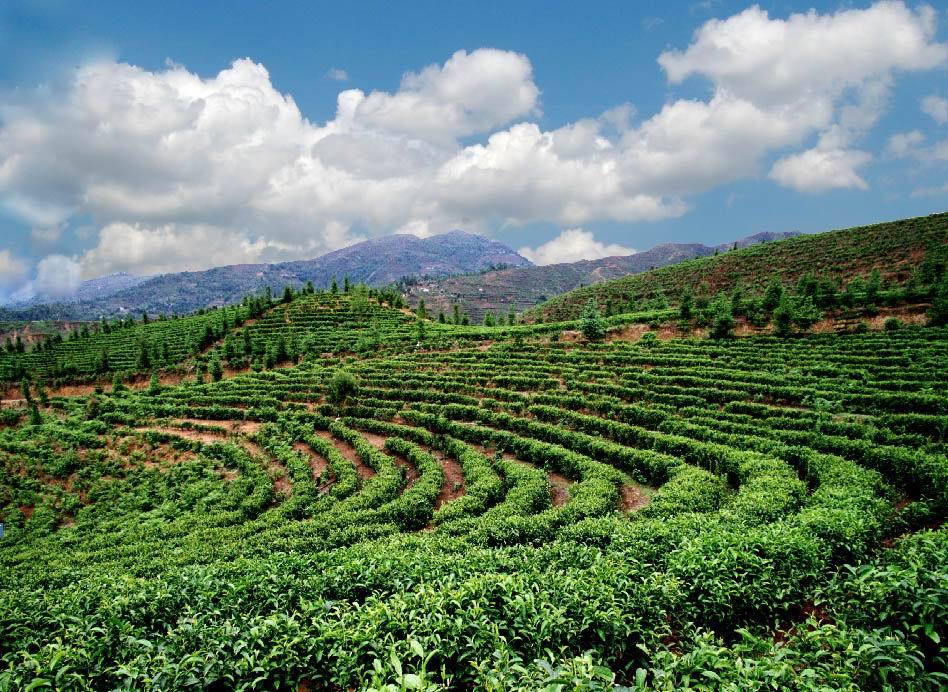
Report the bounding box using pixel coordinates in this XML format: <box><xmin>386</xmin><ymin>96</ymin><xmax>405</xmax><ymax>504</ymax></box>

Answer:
<box><xmin>0</xmin><ymin>0</ymin><xmax>948</xmax><ymax>301</ymax></box>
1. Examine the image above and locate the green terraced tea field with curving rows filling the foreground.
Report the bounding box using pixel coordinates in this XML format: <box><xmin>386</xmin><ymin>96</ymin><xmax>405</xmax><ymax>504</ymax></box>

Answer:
<box><xmin>0</xmin><ymin>314</ymin><xmax>948</xmax><ymax>690</ymax></box>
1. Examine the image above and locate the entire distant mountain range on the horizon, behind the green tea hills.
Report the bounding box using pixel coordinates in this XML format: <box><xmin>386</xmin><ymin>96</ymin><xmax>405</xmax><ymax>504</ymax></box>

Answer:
<box><xmin>0</xmin><ymin>230</ymin><xmax>798</xmax><ymax>321</ymax></box>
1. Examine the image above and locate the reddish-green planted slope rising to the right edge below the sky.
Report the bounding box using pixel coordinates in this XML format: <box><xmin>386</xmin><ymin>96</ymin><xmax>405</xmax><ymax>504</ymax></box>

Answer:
<box><xmin>533</xmin><ymin>213</ymin><xmax>948</xmax><ymax>320</ymax></box>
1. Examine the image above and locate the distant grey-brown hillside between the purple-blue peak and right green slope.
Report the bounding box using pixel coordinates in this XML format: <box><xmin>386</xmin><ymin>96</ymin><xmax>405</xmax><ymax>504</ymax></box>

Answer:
<box><xmin>402</xmin><ymin>231</ymin><xmax>799</xmax><ymax>323</ymax></box>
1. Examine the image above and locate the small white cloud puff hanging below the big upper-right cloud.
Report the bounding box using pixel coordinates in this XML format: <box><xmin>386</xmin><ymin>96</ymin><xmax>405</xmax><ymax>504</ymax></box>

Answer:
<box><xmin>770</xmin><ymin>147</ymin><xmax>872</xmax><ymax>192</ymax></box>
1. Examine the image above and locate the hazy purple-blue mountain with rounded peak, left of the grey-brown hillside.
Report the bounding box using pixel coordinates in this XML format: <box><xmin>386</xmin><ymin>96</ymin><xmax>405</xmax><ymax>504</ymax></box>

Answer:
<box><xmin>0</xmin><ymin>231</ymin><xmax>530</xmax><ymax>321</ymax></box>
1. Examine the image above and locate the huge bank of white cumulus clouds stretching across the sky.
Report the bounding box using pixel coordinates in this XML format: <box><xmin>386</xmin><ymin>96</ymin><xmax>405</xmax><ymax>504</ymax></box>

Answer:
<box><xmin>0</xmin><ymin>2</ymin><xmax>948</xmax><ymax>286</ymax></box>
